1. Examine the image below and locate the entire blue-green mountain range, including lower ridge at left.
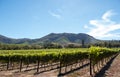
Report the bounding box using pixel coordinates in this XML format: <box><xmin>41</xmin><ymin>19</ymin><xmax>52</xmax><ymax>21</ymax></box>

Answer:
<box><xmin>0</xmin><ymin>33</ymin><xmax>99</xmax><ymax>45</ymax></box>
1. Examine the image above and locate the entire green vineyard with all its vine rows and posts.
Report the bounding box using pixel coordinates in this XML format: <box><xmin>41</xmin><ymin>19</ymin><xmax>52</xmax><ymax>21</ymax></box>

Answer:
<box><xmin>0</xmin><ymin>47</ymin><xmax>120</xmax><ymax>76</ymax></box>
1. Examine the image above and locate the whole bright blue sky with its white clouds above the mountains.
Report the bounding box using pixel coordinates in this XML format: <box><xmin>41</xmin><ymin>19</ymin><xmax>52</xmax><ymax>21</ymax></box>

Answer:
<box><xmin>0</xmin><ymin>0</ymin><xmax>120</xmax><ymax>40</ymax></box>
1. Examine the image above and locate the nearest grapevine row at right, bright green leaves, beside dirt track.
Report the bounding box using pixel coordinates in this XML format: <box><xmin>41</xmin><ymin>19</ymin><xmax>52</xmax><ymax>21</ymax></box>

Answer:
<box><xmin>89</xmin><ymin>47</ymin><xmax>120</xmax><ymax>76</ymax></box>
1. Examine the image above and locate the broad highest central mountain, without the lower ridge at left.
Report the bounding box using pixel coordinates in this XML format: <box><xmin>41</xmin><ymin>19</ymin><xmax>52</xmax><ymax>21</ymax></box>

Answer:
<box><xmin>36</xmin><ymin>33</ymin><xmax>98</xmax><ymax>44</ymax></box>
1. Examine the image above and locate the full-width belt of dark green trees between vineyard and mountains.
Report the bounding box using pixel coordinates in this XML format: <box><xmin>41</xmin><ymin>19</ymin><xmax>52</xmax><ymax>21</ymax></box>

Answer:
<box><xmin>0</xmin><ymin>40</ymin><xmax>120</xmax><ymax>50</ymax></box>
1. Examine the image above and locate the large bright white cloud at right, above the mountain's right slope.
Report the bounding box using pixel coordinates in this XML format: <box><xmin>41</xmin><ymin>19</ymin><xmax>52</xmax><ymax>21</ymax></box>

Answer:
<box><xmin>85</xmin><ymin>10</ymin><xmax>120</xmax><ymax>38</ymax></box>
